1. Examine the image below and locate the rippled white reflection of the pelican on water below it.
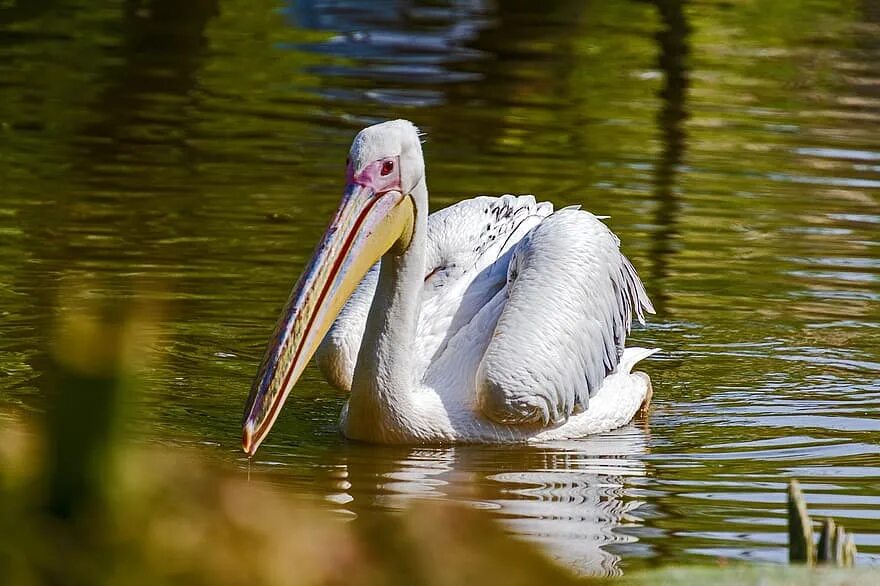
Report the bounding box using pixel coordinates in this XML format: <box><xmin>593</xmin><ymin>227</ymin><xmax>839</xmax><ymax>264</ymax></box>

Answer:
<box><xmin>328</xmin><ymin>425</ymin><xmax>647</xmax><ymax>575</ymax></box>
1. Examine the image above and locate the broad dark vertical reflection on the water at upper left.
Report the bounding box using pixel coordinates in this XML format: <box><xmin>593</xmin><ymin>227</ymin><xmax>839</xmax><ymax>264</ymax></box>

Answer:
<box><xmin>70</xmin><ymin>0</ymin><xmax>220</xmax><ymax>392</ymax></box>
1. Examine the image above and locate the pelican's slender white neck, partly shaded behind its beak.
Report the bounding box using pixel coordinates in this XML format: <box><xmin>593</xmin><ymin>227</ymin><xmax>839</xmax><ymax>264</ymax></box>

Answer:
<box><xmin>346</xmin><ymin>178</ymin><xmax>428</xmax><ymax>440</ymax></box>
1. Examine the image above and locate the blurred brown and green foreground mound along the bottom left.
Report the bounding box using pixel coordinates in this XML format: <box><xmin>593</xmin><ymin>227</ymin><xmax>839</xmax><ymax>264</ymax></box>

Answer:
<box><xmin>0</xmin><ymin>416</ymin><xmax>592</xmax><ymax>586</ymax></box>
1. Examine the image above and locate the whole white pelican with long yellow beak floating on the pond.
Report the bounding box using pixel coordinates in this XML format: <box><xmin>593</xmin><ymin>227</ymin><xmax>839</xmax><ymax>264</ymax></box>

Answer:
<box><xmin>242</xmin><ymin>120</ymin><xmax>656</xmax><ymax>456</ymax></box>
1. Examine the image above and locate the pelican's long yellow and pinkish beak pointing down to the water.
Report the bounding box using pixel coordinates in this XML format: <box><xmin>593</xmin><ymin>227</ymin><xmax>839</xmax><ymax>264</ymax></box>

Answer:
<box><xmin>242</xmin><ymin>183</ymin><xmax>415</xmax><ymax>456</ymax></box>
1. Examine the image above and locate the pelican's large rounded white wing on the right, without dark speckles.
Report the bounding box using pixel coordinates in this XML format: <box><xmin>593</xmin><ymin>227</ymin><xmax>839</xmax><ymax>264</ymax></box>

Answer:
<box><xmin>476</xmin><ymin>209</ymin><xmax>654</xmax><ymax>425</ymax></box>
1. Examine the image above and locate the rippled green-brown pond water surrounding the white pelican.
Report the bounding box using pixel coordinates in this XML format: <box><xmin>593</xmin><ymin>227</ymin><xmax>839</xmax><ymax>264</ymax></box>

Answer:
<box><xmin>0</xmin><ymin>0</ymin><xmax>880</xmax><ymax>573</ymax></box>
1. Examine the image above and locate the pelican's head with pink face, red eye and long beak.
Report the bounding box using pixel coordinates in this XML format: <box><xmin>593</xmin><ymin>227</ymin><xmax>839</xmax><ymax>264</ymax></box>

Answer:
<box><xmin>242</xmin><ymin>120</ymin><xmax>427</xmax><ymax>456</ymax></box>
